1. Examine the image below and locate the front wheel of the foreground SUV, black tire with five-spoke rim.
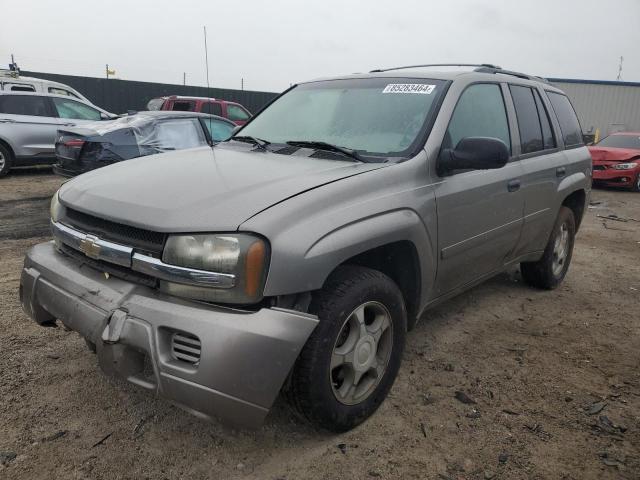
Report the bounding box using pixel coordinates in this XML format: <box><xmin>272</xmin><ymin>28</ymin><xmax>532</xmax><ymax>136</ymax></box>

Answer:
<box><xmin>287</xmin><ymin>266</ymin><xmax>407</xmax><ymax>432</ymax></box>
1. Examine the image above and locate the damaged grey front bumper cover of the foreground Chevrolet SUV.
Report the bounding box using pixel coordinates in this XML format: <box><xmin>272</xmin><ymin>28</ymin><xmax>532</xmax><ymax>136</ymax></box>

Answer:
<box><xmin>20</xmin><ymin>242</ymin><xmax>318</xmax><ymax>427</ymax></box>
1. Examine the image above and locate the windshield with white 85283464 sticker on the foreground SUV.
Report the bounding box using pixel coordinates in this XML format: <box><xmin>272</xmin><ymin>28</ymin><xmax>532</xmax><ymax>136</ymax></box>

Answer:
<box><xmin>239</xmin><ymin>78</ymin><xmax>445</xmax><ymax>157</ymax></box>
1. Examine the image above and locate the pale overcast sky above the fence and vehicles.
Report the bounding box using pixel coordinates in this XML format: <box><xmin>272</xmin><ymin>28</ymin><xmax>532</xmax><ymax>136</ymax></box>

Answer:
<box><xmin>0</xmin><ymin>0</ymin><xmax>640</xmax><ymax>91</ymax></box>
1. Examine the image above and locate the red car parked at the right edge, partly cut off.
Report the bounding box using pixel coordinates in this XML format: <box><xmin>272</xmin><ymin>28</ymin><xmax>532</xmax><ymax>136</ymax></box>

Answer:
<box><xmin>589</xmin><ymin>132</ymin><xmax>640</xmax><ymax>192</ymax></box>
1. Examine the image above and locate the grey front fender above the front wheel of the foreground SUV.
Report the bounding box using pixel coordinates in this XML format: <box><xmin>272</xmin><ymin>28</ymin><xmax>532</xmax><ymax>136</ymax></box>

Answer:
<box><xmin>240</xmin><ymin>158</ymin><xmax>437</xmax><ymax>307</ymax></box>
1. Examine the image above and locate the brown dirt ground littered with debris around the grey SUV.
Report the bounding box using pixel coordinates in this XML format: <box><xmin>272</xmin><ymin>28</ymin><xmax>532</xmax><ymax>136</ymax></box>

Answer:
<box><xmin>0</xmin><ymin>170</ymin><xmax>640</xmax><ymax>480</ymax></box>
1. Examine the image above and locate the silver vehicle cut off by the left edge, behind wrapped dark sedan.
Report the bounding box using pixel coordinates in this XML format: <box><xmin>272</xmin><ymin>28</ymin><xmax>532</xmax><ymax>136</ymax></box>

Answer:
<box><xmin>0</xmin><ymin>92</ymin><xmax>116</xmax><ymax>177</ymax></box>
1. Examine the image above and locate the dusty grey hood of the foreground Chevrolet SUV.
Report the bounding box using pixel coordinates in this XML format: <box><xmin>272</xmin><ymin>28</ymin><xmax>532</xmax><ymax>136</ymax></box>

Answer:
<box><xmin>60</xmin><ymin>145</ymin><xmax>389</xmax><ymax>232</ymax></box>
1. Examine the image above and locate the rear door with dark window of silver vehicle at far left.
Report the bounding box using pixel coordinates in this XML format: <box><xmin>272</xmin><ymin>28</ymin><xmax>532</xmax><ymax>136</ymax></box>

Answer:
<box><xmin>0</xmin><ymin>95</ymin><xmax>58</xmax><ymax>159</ymax></box>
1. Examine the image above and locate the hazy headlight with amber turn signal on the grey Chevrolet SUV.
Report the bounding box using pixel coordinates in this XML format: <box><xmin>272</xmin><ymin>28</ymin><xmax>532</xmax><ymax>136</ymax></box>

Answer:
<box><xmin>160</xmin><ymin>233</ymin><xmax>269</xmax><ymax>304</ymax></box>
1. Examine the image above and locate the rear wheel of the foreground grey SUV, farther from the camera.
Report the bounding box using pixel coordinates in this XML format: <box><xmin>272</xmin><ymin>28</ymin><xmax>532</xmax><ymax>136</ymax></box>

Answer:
<box><xmin>520</xmin><ymin>206</ymin><xmax>576</xmax><ymax>290</ymax></box>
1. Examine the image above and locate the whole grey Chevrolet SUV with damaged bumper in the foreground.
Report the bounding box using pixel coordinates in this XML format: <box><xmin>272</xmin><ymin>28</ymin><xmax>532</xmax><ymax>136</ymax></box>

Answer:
<box><xmin>20</xmin><ymin>62</ymin><xmax>591</xmax><ymax>431</ymax></box>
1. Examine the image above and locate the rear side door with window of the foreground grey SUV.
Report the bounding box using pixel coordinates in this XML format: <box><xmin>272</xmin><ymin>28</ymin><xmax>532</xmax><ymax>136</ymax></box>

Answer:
<box><xmin>509</xmin><ymin>84</ymin><xmax>564</xmax><ymax>257</ymax></box>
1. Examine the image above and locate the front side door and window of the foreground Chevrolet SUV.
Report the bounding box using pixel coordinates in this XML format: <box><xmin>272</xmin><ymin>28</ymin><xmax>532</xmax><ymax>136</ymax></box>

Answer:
<box><xmin>435</xmin><ymin>83</ymin><xmax>524</xmax><ymax>296</ymax></box>
